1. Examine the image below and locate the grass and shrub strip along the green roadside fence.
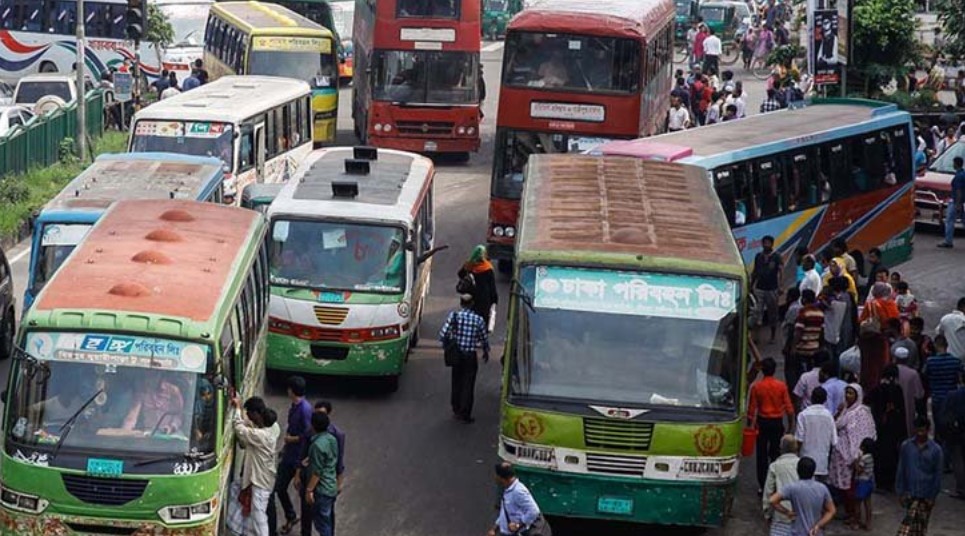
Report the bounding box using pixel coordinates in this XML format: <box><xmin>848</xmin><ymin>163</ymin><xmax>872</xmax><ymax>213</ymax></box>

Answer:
<box><xmin>0</xmin><ymin>131</ymin><xmax>127</xmax><ymax>236</ymax></box>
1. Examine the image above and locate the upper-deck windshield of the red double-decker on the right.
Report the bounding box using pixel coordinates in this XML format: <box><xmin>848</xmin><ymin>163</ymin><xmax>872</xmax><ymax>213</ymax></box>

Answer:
<box><xmin>503</xmin><ymin>32</ymin><xmax>641</xmax><ymax>93</ymax></box>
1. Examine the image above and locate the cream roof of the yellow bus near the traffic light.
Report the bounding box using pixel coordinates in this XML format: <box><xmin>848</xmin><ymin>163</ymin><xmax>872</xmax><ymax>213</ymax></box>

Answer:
<box><xmin>211</xmin><ymin>1</ymin><xmax>332</xmax><ymax>37</ymax></box>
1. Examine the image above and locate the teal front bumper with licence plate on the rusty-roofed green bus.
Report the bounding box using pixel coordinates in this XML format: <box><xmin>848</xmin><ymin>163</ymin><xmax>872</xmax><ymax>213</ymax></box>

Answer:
<box><xmin>515</xmin><ymin>465</ymin><xmax>737</xmax><ymax>527</ymax></box>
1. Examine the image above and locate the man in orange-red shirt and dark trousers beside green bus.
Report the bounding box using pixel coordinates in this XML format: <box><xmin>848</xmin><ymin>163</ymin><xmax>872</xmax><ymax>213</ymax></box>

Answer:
<box><xmin>747</xmin><ymin>357</ymin><xmax>794</xmax><ymax>495</ymax></box>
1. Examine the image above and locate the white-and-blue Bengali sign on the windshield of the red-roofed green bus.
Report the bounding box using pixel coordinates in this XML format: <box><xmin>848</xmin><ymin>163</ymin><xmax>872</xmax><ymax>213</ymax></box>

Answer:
<box><xmin>26</xmin><ymin>332</ymin><xmax>208</xmax><ymax>373</ymax></box>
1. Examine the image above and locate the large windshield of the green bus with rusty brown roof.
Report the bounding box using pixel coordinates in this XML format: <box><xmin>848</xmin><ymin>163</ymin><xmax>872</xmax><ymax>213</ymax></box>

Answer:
<box><xmin>510</xmin><ymin>266</ymin><xmax>741</xmax><ymax>411</ymax></box>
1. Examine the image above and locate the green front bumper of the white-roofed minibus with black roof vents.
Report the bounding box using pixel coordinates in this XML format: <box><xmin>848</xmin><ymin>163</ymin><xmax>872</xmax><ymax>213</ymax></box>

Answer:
<box><xmin>266</xmin><ymin>333</ymin><xmax>410</xmax><ymax>376</ymax></box>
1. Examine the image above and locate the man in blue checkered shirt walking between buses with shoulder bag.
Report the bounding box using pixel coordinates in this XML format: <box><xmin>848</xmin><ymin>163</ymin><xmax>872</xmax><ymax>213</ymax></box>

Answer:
<box><xmin>439</xmin><ymin>294</ymin><xmax>489</xmax><ymax>424</ymax></box>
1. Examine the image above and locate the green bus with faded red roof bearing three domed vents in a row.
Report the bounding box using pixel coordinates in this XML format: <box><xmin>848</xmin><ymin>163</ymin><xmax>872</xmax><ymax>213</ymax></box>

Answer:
<box><xmin>0</xmin><ymin>200</ymin><xmax>269</xmax><ymax>536</ymax></box>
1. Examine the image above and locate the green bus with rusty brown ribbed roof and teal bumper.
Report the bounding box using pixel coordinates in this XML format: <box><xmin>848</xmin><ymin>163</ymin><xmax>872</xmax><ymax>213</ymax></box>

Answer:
<box><xmin>498</xmin><ymin>155</ymin><xmax>747</xmax><ymax>526</ymax></box>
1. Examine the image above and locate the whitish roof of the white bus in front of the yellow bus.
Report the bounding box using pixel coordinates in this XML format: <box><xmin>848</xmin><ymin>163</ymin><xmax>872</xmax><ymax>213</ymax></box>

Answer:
<box><xmin>134</xmin><ymin>75</ymin><xmax>311</xmax><ymax>123</ymax></box>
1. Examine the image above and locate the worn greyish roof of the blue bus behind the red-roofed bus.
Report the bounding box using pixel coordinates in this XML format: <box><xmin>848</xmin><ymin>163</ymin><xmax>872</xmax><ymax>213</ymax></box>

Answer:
<box><xmin>44</xmin><ymin>153</ymin><xmax>224</xmax><ymax>210</ymax></box>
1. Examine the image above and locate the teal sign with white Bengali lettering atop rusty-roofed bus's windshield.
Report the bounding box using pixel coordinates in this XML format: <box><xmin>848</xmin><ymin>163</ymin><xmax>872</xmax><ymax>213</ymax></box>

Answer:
<box><xmin>534</xmin><ymin>266</ymin><xmax>737</xmax><ymax>320</ymax></box>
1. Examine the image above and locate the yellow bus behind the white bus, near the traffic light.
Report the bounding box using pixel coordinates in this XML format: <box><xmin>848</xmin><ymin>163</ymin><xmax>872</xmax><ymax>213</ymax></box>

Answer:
<box><xmin>204</xmin><ymin>1</ymin><xmax>338</xmax><ymax>145</ymax></box>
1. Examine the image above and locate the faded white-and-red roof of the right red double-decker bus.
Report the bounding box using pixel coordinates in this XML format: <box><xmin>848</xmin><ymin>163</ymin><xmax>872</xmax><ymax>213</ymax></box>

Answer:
<box><xmin>507</xmin><ymin>0</ymin><xmax>676</xmax><ymax>39</ymax></box>
